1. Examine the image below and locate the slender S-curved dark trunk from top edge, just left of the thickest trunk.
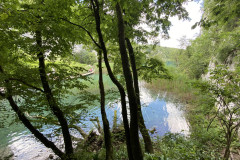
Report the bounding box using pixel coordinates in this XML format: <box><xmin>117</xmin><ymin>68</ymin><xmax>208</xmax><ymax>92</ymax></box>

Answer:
<box><xmin>91</xmin><ymin>0</ymin><xmax>133</xmax><ymax>160</ymax></box>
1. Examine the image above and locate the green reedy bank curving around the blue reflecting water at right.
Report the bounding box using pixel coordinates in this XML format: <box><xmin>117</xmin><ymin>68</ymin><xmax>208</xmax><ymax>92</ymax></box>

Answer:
<box><xmin>142</xmin><ymin>71</ymin><xmax>239</xmax><ymax>159</ymax></box>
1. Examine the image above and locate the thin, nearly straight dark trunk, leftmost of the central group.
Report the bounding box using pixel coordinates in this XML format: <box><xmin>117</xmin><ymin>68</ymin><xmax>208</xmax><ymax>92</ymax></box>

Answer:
<box><xmin>98</xmin><ymin>51</ymin><xmax>113</xmax><ymax>160</ymax></box>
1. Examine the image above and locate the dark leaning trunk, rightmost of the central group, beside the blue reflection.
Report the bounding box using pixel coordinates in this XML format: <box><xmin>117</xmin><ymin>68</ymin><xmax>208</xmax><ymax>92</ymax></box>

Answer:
<box><xmin>126</xmin><ymin>38</ymin><xmax>154</xmax><ymax>153</ymax></box>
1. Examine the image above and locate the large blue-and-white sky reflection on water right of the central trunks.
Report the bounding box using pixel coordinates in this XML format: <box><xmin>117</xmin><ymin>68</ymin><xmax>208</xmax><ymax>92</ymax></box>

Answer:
<box><xmin>141</xmin><ymin>82</ymin><xmax>189</xmax><ymax>136</ymax></box>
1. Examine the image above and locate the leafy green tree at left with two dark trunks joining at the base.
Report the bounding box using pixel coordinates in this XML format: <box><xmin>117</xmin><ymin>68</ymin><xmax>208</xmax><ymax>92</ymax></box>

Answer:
<box><xmin>0</xmin><ymin>1</ymin><xmax>85</xmax><ymax>159</ymax></box>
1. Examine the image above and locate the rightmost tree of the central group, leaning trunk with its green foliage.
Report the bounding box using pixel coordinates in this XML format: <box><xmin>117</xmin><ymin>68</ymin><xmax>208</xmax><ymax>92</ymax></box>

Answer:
<box><xmin>118</xmin><ymin>1</ymin><xmax>186</xmax><ymax>153</ymax></box>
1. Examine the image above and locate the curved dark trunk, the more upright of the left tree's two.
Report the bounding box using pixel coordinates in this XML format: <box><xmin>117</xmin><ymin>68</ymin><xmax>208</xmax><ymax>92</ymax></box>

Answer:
<box><xmin>36</xmin><ymin>30</ymin><xmax>73</xmax><ymax>159</ymax></box>
